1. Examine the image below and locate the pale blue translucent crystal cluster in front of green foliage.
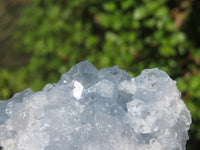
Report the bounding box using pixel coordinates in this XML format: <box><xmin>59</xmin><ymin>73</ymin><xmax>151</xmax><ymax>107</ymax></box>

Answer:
<box><xmin>0</xmin><ymin>61</ymin><xmax>191</xmax><ymax>150</ymax></box>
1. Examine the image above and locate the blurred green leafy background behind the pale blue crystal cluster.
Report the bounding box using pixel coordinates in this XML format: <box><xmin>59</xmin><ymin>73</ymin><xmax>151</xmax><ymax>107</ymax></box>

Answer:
<box><xmin>0</xmin><ymin>0</ymin><xmax>200</xmax><ymax>150</ymax></box>
